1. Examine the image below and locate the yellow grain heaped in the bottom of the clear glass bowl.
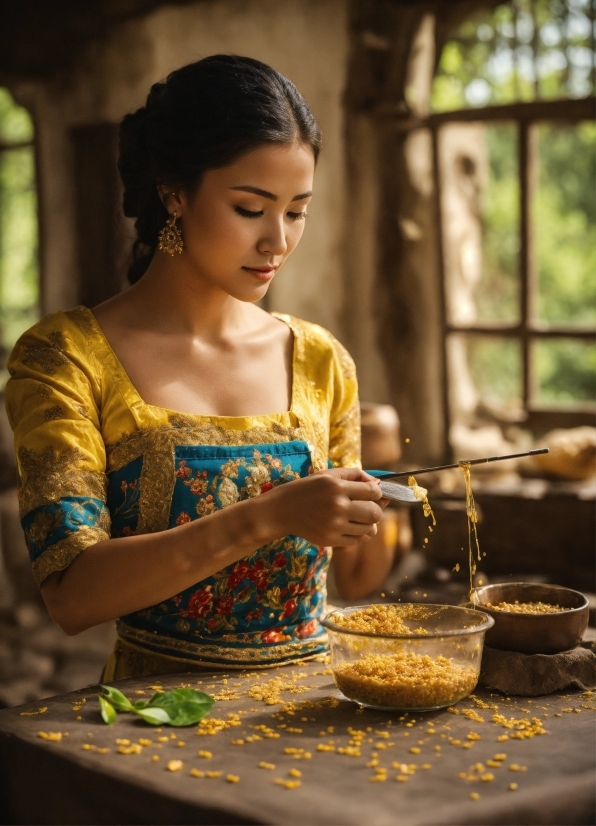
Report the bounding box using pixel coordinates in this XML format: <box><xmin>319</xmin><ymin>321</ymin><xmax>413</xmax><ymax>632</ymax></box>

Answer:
<box><xmin>334</xmin><ymin>651</ymin><xmax>478</xmax><ymax>708</ymax></box>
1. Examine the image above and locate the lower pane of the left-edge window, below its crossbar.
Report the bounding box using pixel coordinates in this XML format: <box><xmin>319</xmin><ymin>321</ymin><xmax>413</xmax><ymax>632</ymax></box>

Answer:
<box><xmin>0</xmin><ymin>147</ymin><xmax>38</xmax><ymax>374</ymax></box>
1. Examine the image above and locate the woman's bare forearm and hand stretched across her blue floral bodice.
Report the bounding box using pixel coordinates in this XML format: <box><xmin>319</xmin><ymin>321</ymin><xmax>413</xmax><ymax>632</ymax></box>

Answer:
<box><xmin>41</xmin><ymin>468</ymin><xmax>382</xmax><ymax>635</ymax></box>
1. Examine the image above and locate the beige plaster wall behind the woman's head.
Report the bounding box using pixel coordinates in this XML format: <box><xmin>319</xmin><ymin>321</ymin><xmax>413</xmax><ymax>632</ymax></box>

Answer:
<box><xmin>14</xmin><ymin>0</ymin><xmax>348</xmax><ymax>337</ymax></box>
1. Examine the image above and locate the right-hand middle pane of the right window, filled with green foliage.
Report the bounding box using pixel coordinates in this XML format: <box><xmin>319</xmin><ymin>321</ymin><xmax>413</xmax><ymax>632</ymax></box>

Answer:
<box><xmin>534</xmin><ymin>123</ymin><xmax>596</xmax><ymax>326</ymax></box>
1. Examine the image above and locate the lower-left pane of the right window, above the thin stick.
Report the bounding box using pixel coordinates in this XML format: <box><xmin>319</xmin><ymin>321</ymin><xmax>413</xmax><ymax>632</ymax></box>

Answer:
<box><xmin>447</xmin><ymin>333</ymin><xmax>522</xmax><ymax>420</ymax></box>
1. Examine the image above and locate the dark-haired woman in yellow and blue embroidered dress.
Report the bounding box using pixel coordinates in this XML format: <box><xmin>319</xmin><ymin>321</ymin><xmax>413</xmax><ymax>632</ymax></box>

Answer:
<box><xmin>6</xmin><ymin>55</ymin><xmax>390</xmax><ymax>680</ymax></box>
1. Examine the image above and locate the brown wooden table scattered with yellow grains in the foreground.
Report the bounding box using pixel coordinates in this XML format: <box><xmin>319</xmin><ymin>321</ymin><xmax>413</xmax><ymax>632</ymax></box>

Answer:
<box><xmin>0</xmin><ymin>662</ymin><xmax>596</xmax><ymax>826</ymax></box>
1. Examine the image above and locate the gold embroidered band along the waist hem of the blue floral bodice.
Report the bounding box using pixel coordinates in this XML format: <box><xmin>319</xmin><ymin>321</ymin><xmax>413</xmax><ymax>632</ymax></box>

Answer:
<box><xmin>116</xmin><ymin>620</ymin><xmax>328</xmax><ymax>668</ymax></box>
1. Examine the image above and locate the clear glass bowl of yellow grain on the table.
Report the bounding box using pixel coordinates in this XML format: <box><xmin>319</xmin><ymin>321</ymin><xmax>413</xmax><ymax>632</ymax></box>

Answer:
<box><xmin>322</xmin><ymin>603</ymin><xmax>495</xmax><ymax>711</ymax></box>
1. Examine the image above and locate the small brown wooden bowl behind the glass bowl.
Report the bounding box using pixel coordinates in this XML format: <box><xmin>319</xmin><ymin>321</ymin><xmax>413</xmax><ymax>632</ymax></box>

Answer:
<box><xmin>476</xmin><ymin>582</ymin><xmax>589</xmax><ymax>654</ymax></box>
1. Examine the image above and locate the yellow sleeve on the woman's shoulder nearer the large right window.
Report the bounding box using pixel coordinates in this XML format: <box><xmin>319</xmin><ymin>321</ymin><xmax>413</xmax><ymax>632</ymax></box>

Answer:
<box><xmin>329</xmin><ymin>337</ymin><xmax>362</xmax><ymax>467</ymax></box>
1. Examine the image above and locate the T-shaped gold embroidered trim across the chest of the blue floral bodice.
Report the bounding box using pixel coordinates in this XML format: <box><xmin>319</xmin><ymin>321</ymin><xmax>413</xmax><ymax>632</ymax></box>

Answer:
<box><xmin>107</xmin><ymin>422</ymin><xmax>304</xmax><ymax>534</ymax></box>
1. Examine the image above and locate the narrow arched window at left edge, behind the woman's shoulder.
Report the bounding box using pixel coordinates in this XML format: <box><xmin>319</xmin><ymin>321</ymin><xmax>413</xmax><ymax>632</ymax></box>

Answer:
<box><xmin>0</xmin><ymin>88</ymin><xmax>39</xmax><ymax>387</ymax></box>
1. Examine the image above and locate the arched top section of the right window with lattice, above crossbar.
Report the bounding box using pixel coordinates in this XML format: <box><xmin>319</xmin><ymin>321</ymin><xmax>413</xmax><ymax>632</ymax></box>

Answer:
<box><xmin>431</xmin><ymin>0</ymin><xmax>594</xmax><ymax>112</ymax></box>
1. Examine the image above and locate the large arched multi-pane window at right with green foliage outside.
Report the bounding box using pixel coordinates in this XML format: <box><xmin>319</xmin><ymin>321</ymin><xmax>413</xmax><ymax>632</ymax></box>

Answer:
<box><xmin>428</xmin><ymin>0</ymin><xmax>596</xmax><ymax>430</ymax></box>
